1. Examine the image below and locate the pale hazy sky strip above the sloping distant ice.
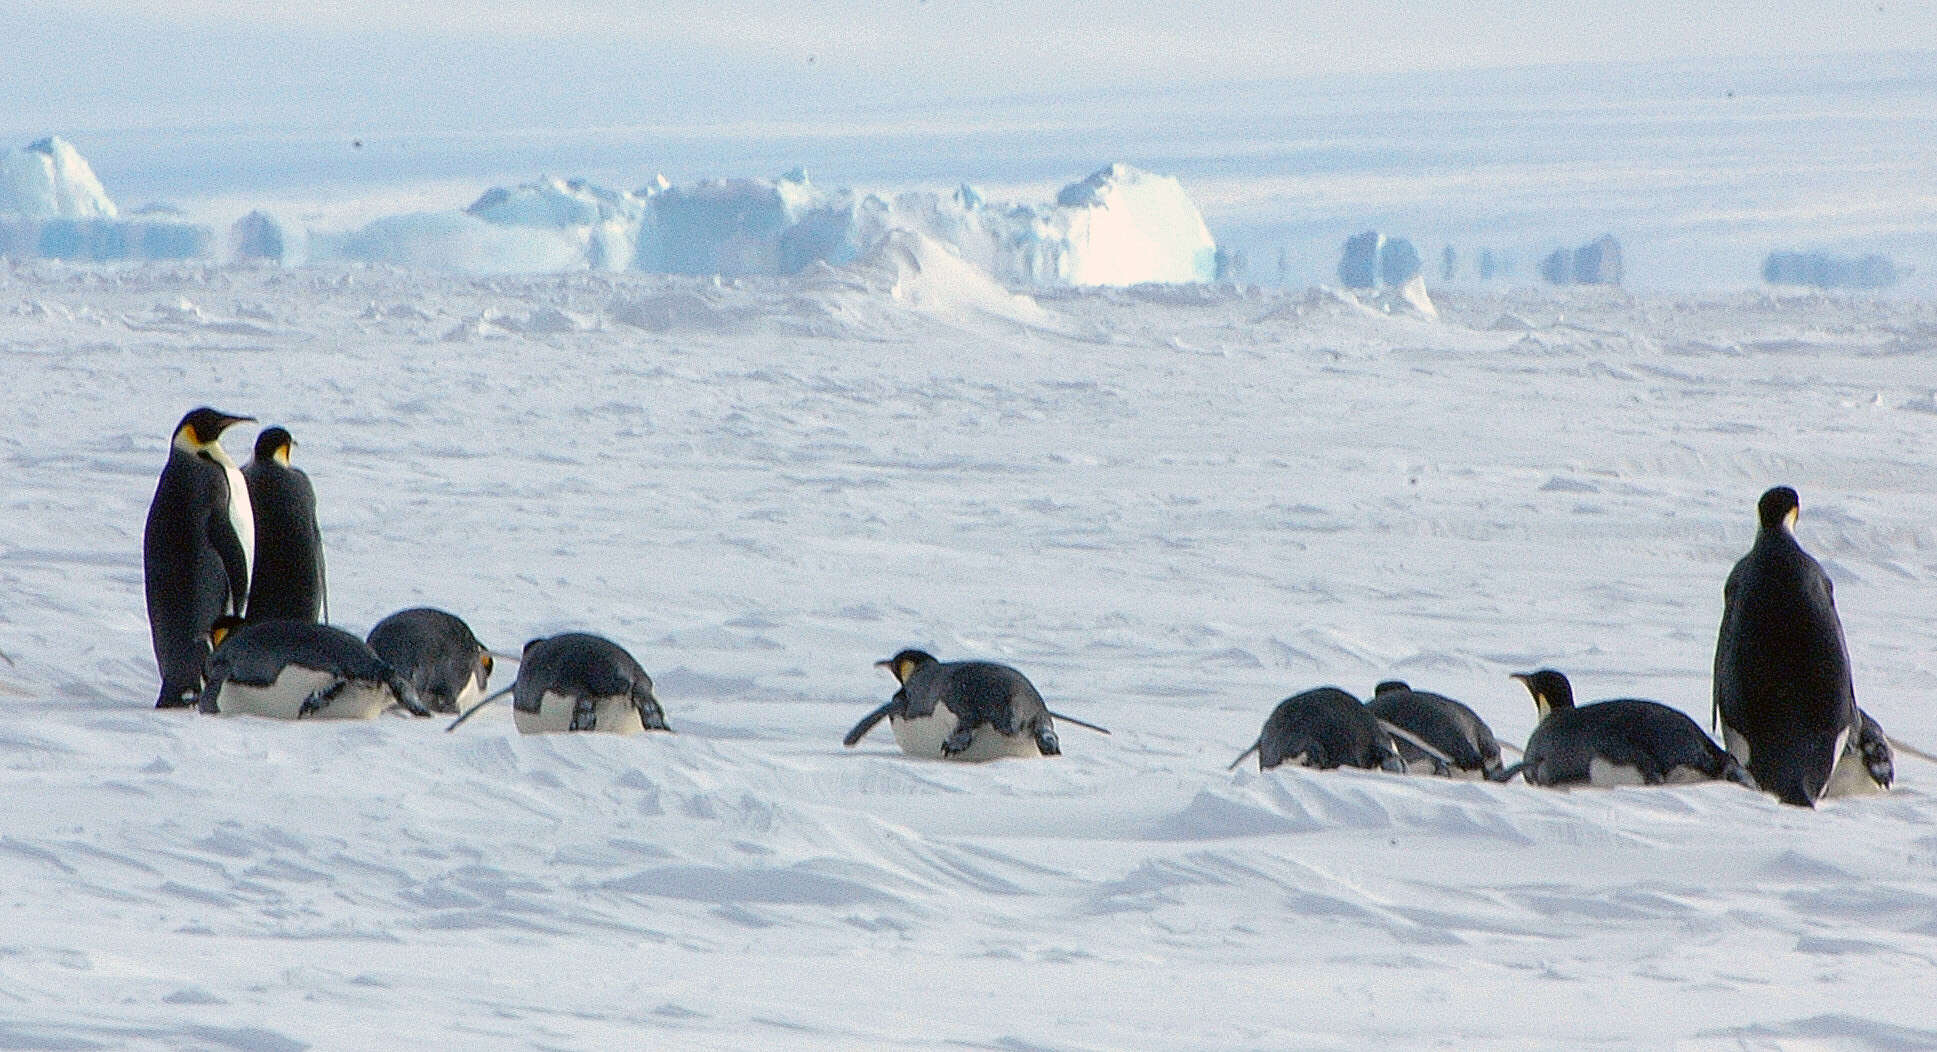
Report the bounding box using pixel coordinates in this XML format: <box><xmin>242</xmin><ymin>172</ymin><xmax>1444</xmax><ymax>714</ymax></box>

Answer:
<box><xmin>0</xmin><ymin>0</ymin><xmax>1937</xmax><ymax>128</ymax></box>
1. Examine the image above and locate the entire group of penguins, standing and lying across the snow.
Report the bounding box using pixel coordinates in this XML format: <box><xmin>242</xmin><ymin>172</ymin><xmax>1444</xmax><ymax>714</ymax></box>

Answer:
<box><xmin>143</xmin><ymin>407</ymin><xmax>1894</xmax><ymax>806</ymax></box>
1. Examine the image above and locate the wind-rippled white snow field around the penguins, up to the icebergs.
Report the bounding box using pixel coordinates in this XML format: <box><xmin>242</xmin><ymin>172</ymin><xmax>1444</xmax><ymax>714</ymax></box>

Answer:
<box><xmin>0</xmin><ymin>257</ymin><xmax>1937</xmax><ymax>1050</ymax></box>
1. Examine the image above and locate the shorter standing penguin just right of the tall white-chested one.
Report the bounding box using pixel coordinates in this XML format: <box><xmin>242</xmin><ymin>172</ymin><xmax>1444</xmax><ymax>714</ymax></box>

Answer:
<box><xmin>242</xmin><ymin>428</ymin><xmax>329</xmax><ymax>622</ymax></box>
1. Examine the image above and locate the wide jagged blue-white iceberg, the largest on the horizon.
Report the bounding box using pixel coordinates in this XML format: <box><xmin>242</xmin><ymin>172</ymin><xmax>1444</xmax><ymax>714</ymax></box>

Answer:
<box><xmin>310</xmin><ymin>165</ymin><xmax>1216</xmax><ymax>287</ymax></box>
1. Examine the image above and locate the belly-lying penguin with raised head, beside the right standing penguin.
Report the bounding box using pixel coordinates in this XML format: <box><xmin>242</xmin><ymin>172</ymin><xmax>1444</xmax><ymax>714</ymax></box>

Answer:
<box><xmin>1493</xmin><ymin>668</ymin><xmax>1755</xmax><ymax>789</ymax></box>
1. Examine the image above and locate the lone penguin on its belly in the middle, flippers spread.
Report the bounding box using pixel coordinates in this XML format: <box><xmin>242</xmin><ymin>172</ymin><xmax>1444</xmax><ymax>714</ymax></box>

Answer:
<box><xmin>841</xmin><ymin>649</ymin><xmax>1108</xmax><ymax>761</ymax></box>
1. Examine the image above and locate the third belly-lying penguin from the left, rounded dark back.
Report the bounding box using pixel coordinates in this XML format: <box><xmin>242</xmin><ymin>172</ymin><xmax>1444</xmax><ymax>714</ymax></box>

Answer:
<box><xmin>507</xmin><ymin>632</ymin><xmax>672</xmax><ymax>734</ymax></box>
